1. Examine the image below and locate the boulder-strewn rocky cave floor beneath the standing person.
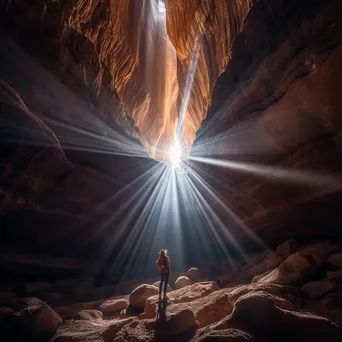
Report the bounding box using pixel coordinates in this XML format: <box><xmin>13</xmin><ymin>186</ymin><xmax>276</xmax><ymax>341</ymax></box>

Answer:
<box><xmin>0</xmin><ymin>240</ymin><xmax>342</xmax><ymax>342</ymax></box>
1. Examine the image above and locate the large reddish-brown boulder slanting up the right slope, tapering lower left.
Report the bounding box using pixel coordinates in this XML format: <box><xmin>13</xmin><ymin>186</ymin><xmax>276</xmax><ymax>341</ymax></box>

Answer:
<box><xmin>257</xmin><ymin>252</ymin><xmax>323</xmax><ymax>285</ymax></box>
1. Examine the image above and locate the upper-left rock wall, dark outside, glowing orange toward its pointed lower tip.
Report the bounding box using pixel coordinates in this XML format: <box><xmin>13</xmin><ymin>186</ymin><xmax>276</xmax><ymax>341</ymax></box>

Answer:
<box><xmin>1</xmin><ymin>0</ymin><xmax>178</xmax><ymax>159</ymax></box>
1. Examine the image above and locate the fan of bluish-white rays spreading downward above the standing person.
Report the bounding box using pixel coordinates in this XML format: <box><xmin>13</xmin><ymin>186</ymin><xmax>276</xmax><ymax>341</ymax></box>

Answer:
<box><xmin>103</xmin><ymin>158</ymin><xmax>266</xmax><ymax>278</ymax></box>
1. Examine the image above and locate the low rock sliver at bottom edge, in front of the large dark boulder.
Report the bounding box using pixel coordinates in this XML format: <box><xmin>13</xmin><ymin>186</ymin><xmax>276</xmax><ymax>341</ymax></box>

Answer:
<box><xmin>191</xmin><ymin>329</ymin><xmax>266</xmax><ymax>342</ymax></box>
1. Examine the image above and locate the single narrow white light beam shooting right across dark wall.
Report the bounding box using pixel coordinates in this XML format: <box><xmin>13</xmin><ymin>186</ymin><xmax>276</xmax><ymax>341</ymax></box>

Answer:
<box><xmin>190</xmin><ymin>157</ymin><xmax>342</xmax><ymax>189</ymax></box>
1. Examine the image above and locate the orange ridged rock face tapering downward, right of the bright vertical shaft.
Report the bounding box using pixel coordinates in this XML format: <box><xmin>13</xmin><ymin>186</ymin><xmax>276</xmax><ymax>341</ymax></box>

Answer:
<box><xmin>165</xmin><ymin>0</ymin><xmax>252</xmax><ymax>151</ymax></box>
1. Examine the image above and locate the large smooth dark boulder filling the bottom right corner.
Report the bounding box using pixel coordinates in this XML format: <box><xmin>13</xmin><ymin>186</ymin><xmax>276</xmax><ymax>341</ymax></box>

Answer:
<box><xmin>204</xmin><ymin>292</ymin><xmax>342</xmax><ymax>342</ymax></box>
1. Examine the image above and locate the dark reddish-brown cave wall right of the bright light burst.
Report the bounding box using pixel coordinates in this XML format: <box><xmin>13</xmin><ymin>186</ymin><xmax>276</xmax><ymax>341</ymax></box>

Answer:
<box><xmin>192</xmin><ymin>1</ymin><xmax>342</xmax><ymax>245</ymax></box>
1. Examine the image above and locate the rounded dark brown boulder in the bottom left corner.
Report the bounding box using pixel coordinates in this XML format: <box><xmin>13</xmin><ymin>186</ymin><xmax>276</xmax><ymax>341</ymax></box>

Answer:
<box><xmin>12</xmin><ymin>298</ymin><xmax>62</xmax><ymax>339</ymax></box>
